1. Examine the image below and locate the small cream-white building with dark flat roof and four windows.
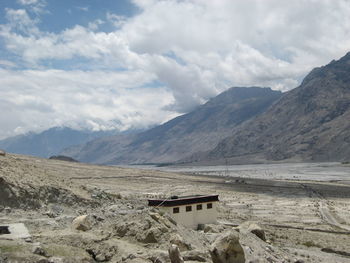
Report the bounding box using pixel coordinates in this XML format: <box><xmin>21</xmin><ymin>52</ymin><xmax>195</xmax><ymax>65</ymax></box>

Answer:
<box><xmin>148</xmin><ymin>195</ymin><xmax>219</xmax><ymax>229</ymax></box>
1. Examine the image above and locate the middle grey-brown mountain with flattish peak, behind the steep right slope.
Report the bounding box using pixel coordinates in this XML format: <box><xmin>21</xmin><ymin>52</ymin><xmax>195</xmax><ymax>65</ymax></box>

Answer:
<box><xmin>62</xmin><ymin>87</ymin><xmax>282</xmax><ymax>164</ymax></box>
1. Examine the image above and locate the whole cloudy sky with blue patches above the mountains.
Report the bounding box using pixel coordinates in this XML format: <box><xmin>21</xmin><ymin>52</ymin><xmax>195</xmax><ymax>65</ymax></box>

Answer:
<box><xmin>0</xmin><ymin>0</ymin><xmax>350</xmax><ymax>139</ymax></box>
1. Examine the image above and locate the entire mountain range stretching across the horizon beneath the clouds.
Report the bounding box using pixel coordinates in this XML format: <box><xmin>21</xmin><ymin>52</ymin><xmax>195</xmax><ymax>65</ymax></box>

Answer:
<box><xmin>0</xmin><ymin>53</ymin><xmax>350</xmax><ymax>164</ymax></box>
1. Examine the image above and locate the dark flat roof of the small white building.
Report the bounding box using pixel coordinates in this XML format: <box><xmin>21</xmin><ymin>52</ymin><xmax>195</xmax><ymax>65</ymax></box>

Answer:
<box><xmin>148</xmin><ymin>195</ymin><xmax>219</xmax><ymax>207</ymax></box>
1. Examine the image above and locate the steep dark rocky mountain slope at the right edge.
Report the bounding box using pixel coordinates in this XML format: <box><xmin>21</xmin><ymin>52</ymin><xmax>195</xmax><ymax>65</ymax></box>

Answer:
<box><xmin>197</xmin><ymin>53</ymin><xmax>350</xmax><ymax>163</ymax></box>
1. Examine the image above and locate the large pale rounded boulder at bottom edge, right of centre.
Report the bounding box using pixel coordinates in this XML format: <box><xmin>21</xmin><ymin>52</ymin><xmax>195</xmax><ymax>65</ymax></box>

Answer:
<box><xmin>209</xmin><ymin>231</ymin><xmax>245</xmax><ymax>263</ymax></box>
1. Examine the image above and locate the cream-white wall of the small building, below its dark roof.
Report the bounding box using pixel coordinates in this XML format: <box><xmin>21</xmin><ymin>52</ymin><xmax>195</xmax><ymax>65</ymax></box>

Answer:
<box><xmin>160</xmin><ymin>202</ymin><xmax>217</xmax><ymax>229</ymax></box>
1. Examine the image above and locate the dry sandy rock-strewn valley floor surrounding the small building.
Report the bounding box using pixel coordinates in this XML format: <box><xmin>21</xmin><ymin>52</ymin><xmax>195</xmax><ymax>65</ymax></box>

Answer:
<box><xmin>0</xmin><ymin>154</ymin><xmax>350</xmax><ymax>263</ymax></box>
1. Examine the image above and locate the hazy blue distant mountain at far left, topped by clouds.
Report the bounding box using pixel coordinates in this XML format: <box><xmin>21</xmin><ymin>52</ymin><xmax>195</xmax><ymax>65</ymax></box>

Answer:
<box><xmin>0</xmin><ymin>127</ymin><xmax>112</xmax><ymax>158</ymax></box>
